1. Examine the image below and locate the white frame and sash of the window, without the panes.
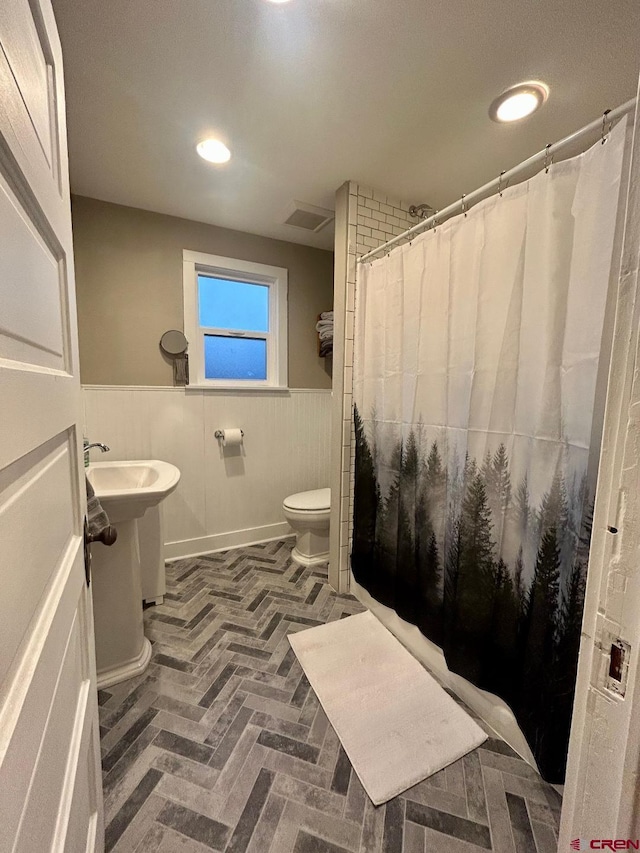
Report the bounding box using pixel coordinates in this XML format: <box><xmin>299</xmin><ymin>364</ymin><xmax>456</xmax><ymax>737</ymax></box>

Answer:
<box><xmin>182</xmin><ymin>249</ymin><xmax>288</xmax><ymax>390</ymax></box>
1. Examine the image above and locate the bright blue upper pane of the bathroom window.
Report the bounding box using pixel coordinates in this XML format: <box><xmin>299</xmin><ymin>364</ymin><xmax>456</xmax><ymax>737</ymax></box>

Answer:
<box><xmin>198</xmin><ymin>275</ymin><xmax>269</xmax><ymax>332</ymax></box>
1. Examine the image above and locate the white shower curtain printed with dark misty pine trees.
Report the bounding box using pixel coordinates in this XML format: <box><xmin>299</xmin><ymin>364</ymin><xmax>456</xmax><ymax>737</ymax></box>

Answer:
<box><xmin>351</xmin><ymin>122</ymin><xmax>625</xmax><ymax>782</ymax></box>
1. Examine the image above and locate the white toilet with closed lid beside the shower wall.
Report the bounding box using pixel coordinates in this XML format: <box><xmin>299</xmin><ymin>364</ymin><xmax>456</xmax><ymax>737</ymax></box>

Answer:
<box><xmin>282</xmin><ymin>489</ymin><xmax>331</xmax><ymax>566</ymax></box>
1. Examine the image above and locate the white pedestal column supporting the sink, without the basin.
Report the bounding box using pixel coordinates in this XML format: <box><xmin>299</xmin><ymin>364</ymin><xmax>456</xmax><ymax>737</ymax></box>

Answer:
<box><xmin>91</xmin><ymin>519</ymin><xmax>151</xmax><ymax>688</ymax></box>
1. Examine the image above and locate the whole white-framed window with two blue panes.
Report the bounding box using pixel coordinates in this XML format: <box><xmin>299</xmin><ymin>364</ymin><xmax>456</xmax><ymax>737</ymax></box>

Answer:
<box><xmin>183</xmin><ymin>250</ymin><xmax>287</xmax><ymax>388</ymax></box>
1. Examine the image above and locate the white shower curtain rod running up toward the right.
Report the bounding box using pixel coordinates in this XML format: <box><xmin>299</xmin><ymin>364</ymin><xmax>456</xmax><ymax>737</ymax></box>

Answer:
<box><xmin>358</xmin><ymin>98</ymin><xmax>636</xmax><ymax>264</ymax></box>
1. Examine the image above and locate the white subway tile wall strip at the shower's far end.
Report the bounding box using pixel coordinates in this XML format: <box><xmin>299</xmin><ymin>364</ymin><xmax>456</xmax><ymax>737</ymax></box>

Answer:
<box><xmin>334</xmin><ymin>181</ymin><xmax>418</xmax><ymax>590</ymax></box>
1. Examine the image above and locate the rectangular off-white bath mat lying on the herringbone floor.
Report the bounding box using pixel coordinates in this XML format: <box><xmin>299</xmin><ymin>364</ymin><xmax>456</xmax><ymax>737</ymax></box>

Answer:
<box><xmin>289</xmin><ymin>611</ymin><xmax>487</xmax><ymax>805</ymax></box>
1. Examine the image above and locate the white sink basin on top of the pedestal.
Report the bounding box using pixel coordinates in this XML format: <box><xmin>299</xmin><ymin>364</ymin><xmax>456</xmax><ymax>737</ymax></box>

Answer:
<box><xmin>87</xmin><ymin>459</ymin><xmax>180</xmax><ymax>524</ymax></box>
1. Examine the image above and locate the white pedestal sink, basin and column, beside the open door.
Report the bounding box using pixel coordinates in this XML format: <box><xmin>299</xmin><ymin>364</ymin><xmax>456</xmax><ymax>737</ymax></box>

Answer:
<box><xmin>87</xmin><ymin>459</ymin><xmax>180</xmax><ymax>688</ymax></box>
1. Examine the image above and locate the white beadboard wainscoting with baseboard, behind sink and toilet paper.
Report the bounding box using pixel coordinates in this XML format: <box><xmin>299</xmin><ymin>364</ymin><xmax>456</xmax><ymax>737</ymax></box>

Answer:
<box><xmin>83</xmin><ymin>385</ymin><xmax>331</xmax><ymax>559</ymax></box>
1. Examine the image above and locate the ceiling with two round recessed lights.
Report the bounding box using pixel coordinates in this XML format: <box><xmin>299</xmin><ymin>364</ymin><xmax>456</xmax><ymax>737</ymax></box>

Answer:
<box><xmin>54</xmin><ymin>0</ymin><xmax>640</xmax><ymax>248</ymax></box>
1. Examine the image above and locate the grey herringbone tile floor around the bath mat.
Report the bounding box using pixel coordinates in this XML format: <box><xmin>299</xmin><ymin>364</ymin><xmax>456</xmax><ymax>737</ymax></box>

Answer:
<box><xmin>99</xmin><ymin>540</ymin><xmax>560</xmax><ymax>853</ymax></box>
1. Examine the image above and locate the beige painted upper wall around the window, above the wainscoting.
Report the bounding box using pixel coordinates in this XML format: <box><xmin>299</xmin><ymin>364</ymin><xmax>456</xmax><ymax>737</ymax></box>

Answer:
<box><xmin>72</xmin><ymin>196</ymin><xmax>333</xmax><ymax>388</ymax></box>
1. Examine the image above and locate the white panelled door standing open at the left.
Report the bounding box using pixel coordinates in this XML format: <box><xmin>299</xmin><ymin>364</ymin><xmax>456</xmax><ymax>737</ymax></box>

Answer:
<box><xmin>0</xmin><ymin>0</ymin><xmax>104</xmax><ymax>853</ymax></box>
